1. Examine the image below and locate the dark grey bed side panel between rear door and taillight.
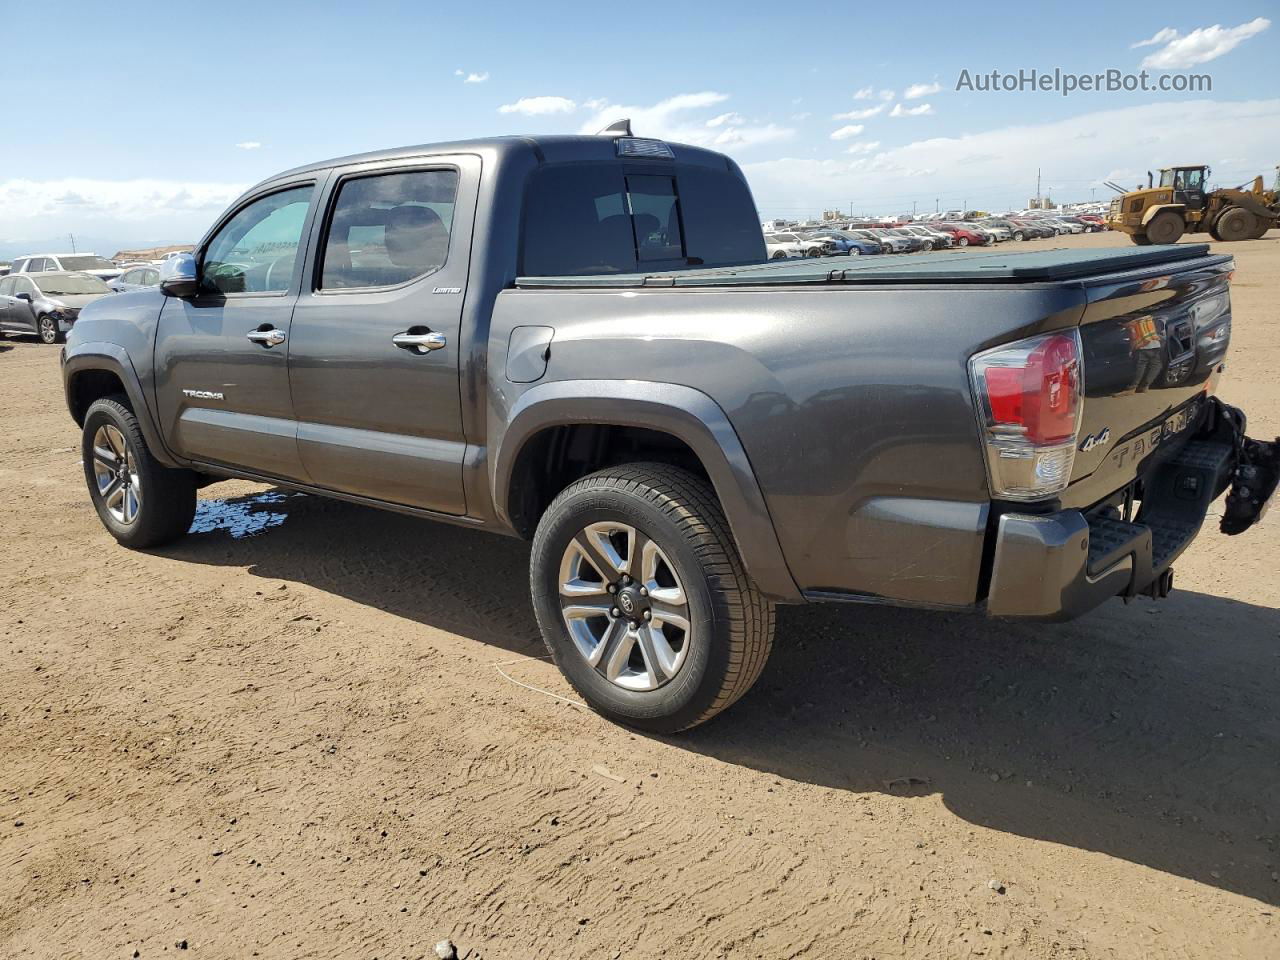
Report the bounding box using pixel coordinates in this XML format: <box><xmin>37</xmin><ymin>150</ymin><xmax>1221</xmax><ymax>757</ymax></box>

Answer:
<box><xmin>490</xmin><ymin>284</ymin><xmax>1083</xmax><ymax>605</ymax></box>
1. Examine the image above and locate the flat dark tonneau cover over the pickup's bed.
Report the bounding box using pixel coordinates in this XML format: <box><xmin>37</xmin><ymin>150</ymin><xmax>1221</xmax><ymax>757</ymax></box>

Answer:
<box><xmin>516</xmin><ymin>243</ymin><xmax>1208</xmax><ymax>288</ymax></box>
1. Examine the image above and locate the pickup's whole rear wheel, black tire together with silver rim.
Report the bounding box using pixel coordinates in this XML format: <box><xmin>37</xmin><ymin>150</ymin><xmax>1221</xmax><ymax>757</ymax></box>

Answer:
<box><xmin>530</xmin><ymin>463</ymin><xmax>773</xmax><ymax>733</ymax></box>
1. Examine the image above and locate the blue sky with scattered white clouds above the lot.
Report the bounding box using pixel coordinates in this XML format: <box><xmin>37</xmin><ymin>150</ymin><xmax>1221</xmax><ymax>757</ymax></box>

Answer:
<box><xmin>0</xmin><ymin>0</ymin><xmax>1280</xmax><ymax>256</ymax></box>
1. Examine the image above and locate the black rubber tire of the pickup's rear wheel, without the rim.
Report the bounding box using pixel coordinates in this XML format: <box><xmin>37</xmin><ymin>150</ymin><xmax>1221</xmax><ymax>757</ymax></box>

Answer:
<box><xmin>530</xmin><ymin>463</ymin><xmax>774</xmax><ymax>733</ymax></box>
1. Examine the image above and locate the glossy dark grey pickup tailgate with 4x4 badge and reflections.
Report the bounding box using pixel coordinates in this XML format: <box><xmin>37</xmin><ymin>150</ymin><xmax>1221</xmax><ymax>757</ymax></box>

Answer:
<box><xmin>1061</xmin><ymin>256</ymin><xmax>1233</xmax><ymax>507</ymax></box>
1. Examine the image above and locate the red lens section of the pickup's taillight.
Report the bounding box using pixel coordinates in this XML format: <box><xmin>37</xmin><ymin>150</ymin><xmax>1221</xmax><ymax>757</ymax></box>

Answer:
<box><xmin>983</xmin><ymin>334</ymin><xmax>1080</xmax><ymax>444</ymax></box>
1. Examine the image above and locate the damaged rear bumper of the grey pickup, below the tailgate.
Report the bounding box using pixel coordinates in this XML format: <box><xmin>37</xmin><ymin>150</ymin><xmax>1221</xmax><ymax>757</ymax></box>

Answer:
<box><xmin>987</xmin><ymin>406</ymin><xmax>1274</xmax><ymax>620</ymax></box>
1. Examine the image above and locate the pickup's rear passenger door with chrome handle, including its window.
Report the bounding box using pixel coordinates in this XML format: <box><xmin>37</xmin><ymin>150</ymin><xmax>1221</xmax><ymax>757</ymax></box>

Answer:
<box><xmin>289</xmin><ymin>156</ymin><xmax>480</xmax><ymax>515</ymax></box>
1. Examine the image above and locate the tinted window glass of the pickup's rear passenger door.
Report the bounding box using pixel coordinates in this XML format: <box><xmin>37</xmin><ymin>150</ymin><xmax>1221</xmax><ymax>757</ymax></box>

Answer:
<box><xmin>320</xmin><ymin>170</ymin><xmax>458</xmax><ymax>289</ymax></box>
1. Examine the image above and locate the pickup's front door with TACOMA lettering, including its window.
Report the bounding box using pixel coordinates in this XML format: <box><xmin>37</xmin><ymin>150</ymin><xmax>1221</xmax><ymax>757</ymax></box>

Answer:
<box><xmin>155</xmin><ymin>179</ymin><xmax>317</xmax><ymax>480</ymax></box>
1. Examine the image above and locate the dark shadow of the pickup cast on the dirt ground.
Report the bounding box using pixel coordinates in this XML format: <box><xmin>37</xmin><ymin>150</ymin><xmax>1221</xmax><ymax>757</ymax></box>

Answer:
<box><xmin>165</xmin><ymin>492</ymin><xmax>1280</xmax><ymax>904</ymax></box>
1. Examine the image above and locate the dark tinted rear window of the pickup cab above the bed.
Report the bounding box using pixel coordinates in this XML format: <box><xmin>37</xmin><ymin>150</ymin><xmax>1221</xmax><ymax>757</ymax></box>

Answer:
<box><xmin>520</xmin><ymin>164</ymin><xmax>765</xmax><ymax>276</ymax></box>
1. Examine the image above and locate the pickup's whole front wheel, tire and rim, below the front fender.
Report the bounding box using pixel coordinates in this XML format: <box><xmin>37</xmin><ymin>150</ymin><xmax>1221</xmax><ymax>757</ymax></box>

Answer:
<box><xmin>81</xmin><ymin>397</ymin><xmax>196</xmax><ymax>549</ymax></box>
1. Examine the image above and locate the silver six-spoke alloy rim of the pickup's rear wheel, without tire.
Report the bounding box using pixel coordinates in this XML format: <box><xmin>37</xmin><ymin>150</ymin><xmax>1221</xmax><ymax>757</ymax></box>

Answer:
<box><xmin>559</xmin><ymin>522</ymin><xmax>695</xmax><ymax>692</ymax></box>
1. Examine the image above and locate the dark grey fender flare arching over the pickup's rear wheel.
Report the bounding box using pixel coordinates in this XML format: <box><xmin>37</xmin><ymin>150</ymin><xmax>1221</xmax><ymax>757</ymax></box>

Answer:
<box><xmin>489</xmin><ymin>380</ymin><xmax>804</xmax><ymax>602</ymax></box>
